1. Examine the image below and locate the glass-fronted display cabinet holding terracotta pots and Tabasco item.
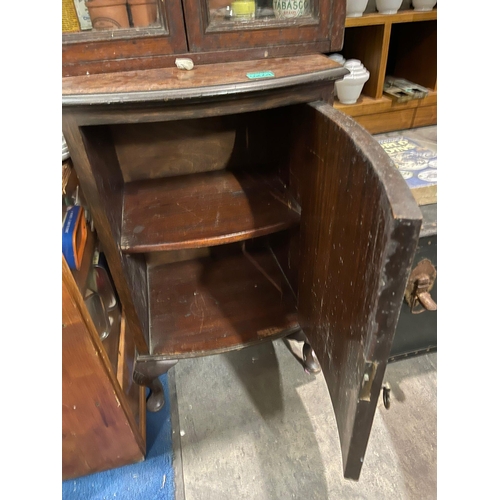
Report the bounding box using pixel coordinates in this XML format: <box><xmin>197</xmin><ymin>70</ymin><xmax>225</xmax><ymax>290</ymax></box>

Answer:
<box><xmin>62</xmin><ymin>0</ymin><xmax>345</xmax><ymax>76</ymax></box>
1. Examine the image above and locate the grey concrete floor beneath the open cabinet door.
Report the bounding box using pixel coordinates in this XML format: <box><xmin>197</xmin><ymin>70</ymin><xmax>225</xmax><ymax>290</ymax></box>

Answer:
<box><xmin>173</xmin><ymin>340</ymin><xmax>437</xmax><ymax>500</ymax></box>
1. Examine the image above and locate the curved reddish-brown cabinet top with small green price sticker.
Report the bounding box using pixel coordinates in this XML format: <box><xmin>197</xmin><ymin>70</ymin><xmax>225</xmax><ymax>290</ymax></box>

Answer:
<box><xmin>62</xmin><ymin>54</ymin><xmax>348</xmax><ymax>105</ymax></box>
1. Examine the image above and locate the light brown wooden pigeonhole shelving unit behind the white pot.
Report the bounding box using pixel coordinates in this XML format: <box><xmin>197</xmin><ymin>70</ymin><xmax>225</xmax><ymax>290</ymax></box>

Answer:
<box><xmin>334</xmin><ymin>9</ymin><xmax>437</xmax><ymax>134</ymax></box>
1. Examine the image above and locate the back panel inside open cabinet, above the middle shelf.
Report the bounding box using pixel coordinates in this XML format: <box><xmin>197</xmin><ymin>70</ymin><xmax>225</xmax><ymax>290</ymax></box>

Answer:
<box><xmin>109</xmin><ymin>109</ymin><xmax>302</xmax><ymax>183</ymax></box>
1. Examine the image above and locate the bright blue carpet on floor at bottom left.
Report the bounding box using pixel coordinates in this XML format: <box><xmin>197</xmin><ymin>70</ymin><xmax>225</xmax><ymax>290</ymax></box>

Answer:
<box><xmin>62</xmin><ymin>374</ymin><xmax>175</xmax><ymax>500</ymax></box>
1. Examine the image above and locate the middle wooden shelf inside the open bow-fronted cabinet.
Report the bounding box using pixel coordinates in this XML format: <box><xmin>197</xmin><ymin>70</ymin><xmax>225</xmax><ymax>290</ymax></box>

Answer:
<box><xmin>121</xmin><ymin>170</ymin><xmax>300</xmax><ymax>253</ymax></box>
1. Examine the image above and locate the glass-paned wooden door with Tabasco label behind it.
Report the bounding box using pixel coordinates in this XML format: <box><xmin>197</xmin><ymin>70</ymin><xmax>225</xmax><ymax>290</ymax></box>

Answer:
<box><xmin>184</xmin><ymin>0</ymin><xmax>336</xmax><ymax>52</ymax></box>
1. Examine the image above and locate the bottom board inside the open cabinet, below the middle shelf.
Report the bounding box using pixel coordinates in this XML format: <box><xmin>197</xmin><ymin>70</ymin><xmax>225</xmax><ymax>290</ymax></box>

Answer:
<box><xmin>149</xmin><ymin>247</ymin><xmax>299</xmax><ymax>358</ymax></box>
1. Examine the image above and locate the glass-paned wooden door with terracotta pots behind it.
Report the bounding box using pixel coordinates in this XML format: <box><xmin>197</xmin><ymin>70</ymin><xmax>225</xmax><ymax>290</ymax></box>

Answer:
<box><xmin>62</xmin><ymin>0</ymin><xmax>187</xmax><ymax>76</ymax></box>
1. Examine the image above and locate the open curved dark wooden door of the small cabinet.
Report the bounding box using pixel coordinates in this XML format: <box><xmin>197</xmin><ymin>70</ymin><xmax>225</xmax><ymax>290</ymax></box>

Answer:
<box><xmin>290</xmin><ymin>103</ymin><xmax>421</xmax><ymax>479</ymax></box>
